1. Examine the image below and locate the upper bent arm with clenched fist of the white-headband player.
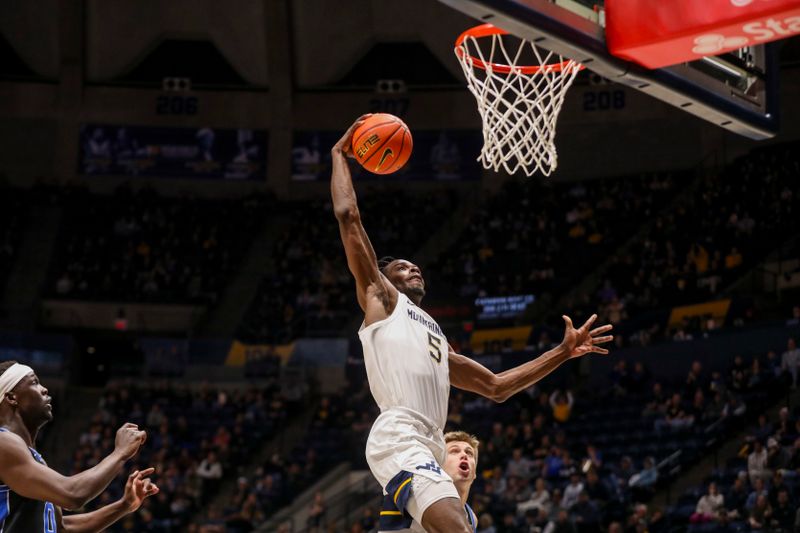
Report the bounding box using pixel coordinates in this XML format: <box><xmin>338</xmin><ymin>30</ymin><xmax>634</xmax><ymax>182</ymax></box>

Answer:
<box><xmin>0</xmin><ymin>424</ymin><xmax>146</xmax><ymax>509</ymax></box>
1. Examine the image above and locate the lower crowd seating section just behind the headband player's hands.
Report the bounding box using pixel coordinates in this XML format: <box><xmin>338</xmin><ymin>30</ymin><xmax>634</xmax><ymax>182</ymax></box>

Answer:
<box><xmin>72</xmin><ymin>381</ymin><xmax>294</xmax><ymax>533</ymax></box>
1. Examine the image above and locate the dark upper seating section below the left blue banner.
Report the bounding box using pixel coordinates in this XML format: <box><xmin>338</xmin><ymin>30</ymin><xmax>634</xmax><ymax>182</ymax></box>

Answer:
<box><xmin>47</xmin><ymin>187</ymin><xmax>271</xmax><ymax>304</ymax></box>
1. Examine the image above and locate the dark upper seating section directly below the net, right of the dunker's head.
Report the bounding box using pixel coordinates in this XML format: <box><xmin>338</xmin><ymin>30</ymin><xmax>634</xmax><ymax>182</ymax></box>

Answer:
<box><xmin>430</xmin><ymin>170</ymin><xmax>688</xmax><ymax>301</ymax></box>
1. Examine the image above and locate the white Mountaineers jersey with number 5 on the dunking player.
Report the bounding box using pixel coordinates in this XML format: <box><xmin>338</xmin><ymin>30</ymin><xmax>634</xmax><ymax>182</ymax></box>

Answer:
<box><xmin>358</xmin><ymin>293</ymin><xmax>450</xmax><ymax>428</ymax></box>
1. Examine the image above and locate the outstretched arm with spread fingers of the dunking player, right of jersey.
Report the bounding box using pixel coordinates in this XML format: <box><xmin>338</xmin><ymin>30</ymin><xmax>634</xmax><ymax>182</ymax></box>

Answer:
<box><xmin>448</xmin><ymin>315</ymin><xmax>614</xmax><ymax>402</ymax></box>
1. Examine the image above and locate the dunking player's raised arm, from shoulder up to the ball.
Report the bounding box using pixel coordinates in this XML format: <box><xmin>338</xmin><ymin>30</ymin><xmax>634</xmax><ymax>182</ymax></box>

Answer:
<box><xmin>331</xmin><ymin>115</ymin><xmax>397</xmax><ymax>316</ymax></box>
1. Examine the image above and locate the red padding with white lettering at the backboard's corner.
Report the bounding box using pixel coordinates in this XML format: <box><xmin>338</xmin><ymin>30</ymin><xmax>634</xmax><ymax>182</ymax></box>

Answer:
<box><xmin>605</xmin><ymin>0</ymin><xmax>800</xmax><ymax>69</ymax></box>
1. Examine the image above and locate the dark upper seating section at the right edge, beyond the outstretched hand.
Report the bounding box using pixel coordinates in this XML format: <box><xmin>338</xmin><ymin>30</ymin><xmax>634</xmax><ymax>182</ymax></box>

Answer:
<box><xmin>592</xmin><ymin>143</ymin><xmax>800</xmax><ymax>343</ymax></box>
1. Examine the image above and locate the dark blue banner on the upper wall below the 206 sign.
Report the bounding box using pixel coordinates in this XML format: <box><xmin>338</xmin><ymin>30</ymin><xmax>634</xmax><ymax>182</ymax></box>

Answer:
<box><xmin>78</xmin><ymin>124</ymin><xmax>267</xmax><ymax>180</ymax></box>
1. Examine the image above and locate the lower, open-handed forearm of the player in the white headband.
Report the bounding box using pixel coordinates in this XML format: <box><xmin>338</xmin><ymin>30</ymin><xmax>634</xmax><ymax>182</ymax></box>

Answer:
<box><xmin>59</xmin><ymin>468</ymin><xmax>159</xmax><ymax>533</ymax></box>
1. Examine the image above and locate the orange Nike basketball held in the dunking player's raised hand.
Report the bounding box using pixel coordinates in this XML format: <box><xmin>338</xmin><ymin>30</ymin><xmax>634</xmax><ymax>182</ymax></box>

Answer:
<box><xmin>353</xmin><ymin>113</ymin><xmax>414</xmax><ymax>174</ymax></box>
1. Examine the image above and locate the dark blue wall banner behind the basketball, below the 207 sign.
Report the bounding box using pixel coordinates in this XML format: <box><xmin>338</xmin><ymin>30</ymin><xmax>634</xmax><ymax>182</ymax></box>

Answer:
<box><xmin>292</xmin><ymin>130</ymin><xmax>483</xmax><ymax>181</ymax></box>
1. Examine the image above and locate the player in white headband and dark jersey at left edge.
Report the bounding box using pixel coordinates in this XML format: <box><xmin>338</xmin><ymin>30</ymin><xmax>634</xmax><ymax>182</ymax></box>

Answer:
<box><xmin>0</xmin><ymin>361</ymin><xmax>158</xmax><ymax>533</ymax></box>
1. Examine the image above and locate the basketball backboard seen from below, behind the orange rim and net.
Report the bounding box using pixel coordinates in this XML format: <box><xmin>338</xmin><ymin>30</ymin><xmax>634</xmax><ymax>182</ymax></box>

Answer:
<box><xmin>439</xmin><ymin>0</ymin><xmax>778</xmax><ymax>139</ymax></box>
